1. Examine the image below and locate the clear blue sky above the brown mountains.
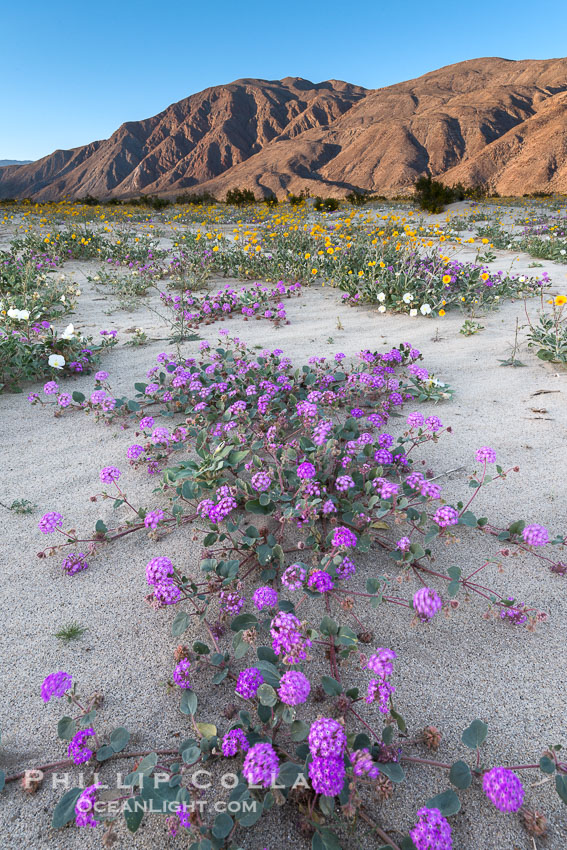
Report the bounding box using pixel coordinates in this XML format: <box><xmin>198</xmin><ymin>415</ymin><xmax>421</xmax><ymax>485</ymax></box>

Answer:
<box><xmin>0</xmin><ymin>0</ymin><xmax>567</xmax><ymax>159</ymax></box>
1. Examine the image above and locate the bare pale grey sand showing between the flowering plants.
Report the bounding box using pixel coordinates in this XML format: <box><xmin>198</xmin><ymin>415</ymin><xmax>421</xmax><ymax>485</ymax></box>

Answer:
<box><xmin>0</xmin><ymin>222</ymin><xmax>567</xmax><ymax>850</ymax></box>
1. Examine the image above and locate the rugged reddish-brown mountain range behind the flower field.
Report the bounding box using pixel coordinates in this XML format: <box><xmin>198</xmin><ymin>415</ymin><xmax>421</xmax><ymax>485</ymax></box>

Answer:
<box><xmin>0</xmin><ymin>58</ymin><xmax>567</xmax><ymax>200</ymax></box>
